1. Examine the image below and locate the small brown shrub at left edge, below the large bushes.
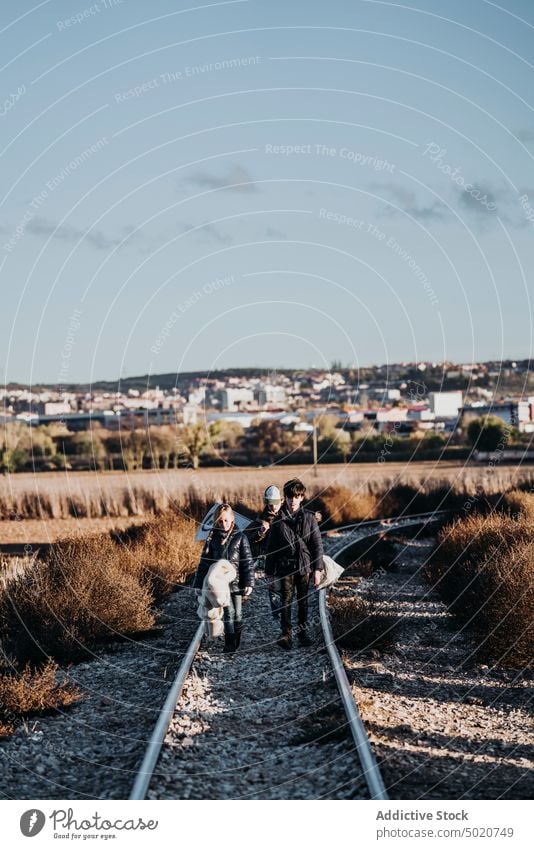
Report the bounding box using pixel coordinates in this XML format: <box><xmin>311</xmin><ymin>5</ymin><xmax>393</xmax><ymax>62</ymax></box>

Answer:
<box><xmin>0</xmin><ymin>661</ymin><xmax>81</xmax><ymax>737</ymax></box>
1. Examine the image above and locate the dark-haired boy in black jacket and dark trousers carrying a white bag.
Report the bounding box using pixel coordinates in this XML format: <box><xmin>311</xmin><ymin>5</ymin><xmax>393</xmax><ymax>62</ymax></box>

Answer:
<box><xmin>265</xmin><ymin>478</ymin><xmax>323</xmax><ymax>650</ymax></box>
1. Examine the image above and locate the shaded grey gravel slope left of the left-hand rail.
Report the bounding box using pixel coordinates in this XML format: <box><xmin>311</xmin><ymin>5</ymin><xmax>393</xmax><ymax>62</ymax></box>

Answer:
<box><xmin>0</xmin><ymin>587</ymin><xmax>198</xmax><ymax>799</ymax></box>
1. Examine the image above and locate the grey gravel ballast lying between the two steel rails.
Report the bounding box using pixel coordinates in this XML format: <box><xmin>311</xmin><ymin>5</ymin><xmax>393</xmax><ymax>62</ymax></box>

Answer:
<box><xmin>148</xmin><ymin>568</ymin><xmax>368</xmax><ymax>799</ymax></box>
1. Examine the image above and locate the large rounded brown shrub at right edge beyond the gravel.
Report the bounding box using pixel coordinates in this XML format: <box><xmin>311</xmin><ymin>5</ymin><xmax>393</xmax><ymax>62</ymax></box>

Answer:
<box><xmin>427</xmin><ymin>513</ymin><xmax>534</xmax><ymax>667</ymax></box>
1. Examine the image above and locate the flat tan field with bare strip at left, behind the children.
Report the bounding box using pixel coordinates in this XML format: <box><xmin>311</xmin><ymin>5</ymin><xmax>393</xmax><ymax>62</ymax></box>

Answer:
<box><xmin>0</xmin><ymin>462</ymin><xmax>534</xmax><ymax>544</ymax></box>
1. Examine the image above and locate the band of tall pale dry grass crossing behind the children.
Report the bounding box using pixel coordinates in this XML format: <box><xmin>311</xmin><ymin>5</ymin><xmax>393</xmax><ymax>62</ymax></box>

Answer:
<box><xmin>0</xmin><ymin>461</ymin><xmax>534</xmax><ymax>521</ymax></box>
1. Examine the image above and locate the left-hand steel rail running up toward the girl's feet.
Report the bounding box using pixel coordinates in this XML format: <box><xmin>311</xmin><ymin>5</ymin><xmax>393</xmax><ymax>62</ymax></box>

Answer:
<box><xmin>129</xmin><ymin>622</ymin><xmax>204</xmax><ymax>800</ymax></box>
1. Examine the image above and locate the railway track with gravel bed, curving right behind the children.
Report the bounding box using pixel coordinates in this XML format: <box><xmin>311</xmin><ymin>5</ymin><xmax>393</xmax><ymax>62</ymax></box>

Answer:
<box><xmin>130</xmin><ymin>511</ymin><xmax>447</xmax><ymax>800</ymax></box>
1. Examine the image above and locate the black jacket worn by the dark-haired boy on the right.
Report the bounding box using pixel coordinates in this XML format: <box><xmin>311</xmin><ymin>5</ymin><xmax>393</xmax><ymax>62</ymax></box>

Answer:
<box><xmin>265</xmin><ymin>506</ymin><xmax>323</xmax><ymax>578</ymax></box>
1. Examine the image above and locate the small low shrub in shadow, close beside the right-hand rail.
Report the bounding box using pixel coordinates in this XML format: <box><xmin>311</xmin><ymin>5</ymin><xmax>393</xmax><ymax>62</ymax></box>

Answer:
<box><xmin>329</xmin><ymin>595</ymin><xmax>399</xmax><ymax>652</ymax></box>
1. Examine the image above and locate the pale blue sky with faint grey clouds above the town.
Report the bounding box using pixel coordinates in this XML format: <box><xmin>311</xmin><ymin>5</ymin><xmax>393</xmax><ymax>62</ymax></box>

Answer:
<box><xmin>0</xmin><ymin>0</ymin><xmax>534</xmax><ymax>383</ymax></box>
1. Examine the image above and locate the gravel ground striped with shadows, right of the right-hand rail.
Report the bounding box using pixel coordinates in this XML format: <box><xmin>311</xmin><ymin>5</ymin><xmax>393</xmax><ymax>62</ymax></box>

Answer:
<box><xmin>333</xmin><ymin>538</ymin><xmax>534</xmax><ymax>799</ymax></box>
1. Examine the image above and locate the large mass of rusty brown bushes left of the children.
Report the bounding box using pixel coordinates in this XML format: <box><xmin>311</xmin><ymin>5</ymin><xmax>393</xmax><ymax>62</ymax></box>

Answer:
<box><xmin>0</xmin><ymin>506</ymin><xmax>199</xmax><ymax>664</ymax></box>
